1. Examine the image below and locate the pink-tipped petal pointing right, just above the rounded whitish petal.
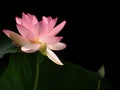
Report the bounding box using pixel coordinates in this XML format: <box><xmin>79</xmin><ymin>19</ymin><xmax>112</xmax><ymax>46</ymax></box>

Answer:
<box><xmin>39</xmin><ymin>36</ymin><xmax>63</xmax><ymax>45</ymax></box>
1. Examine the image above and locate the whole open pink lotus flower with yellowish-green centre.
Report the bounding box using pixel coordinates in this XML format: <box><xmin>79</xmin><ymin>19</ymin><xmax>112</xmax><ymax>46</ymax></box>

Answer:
<box><xmin>3</xmin><ymin>13</ymin><xmax>66</xmax><ymax>65</ymax></box>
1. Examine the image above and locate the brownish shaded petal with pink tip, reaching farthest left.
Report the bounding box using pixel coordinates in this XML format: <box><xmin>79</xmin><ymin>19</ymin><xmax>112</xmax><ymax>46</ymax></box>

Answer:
<box><xmin>3</xmin><ymin>30</ymin><xmax>30</xmax><ymax>46</ymax></box>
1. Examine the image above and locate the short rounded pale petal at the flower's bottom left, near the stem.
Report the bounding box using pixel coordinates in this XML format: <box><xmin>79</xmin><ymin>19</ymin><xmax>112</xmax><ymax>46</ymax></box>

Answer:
<box><xmin>21</xmin><ymin>44</ymin><xmax>40</xmax><ymax>53</ymax></box>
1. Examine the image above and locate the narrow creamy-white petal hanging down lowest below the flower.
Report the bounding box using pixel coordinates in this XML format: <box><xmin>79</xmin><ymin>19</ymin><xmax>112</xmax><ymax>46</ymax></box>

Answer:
<box><xmin>47</xmin><ymin>49</ymin><xmax>63</xmax><ymax>65</ymax></box>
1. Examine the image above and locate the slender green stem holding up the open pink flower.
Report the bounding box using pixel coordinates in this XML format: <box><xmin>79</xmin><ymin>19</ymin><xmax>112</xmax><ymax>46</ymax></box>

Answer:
<box><xmin>34</xmin><ymin>53</ymin><xmax>42</xmax><ymax>90</ymax></box>
